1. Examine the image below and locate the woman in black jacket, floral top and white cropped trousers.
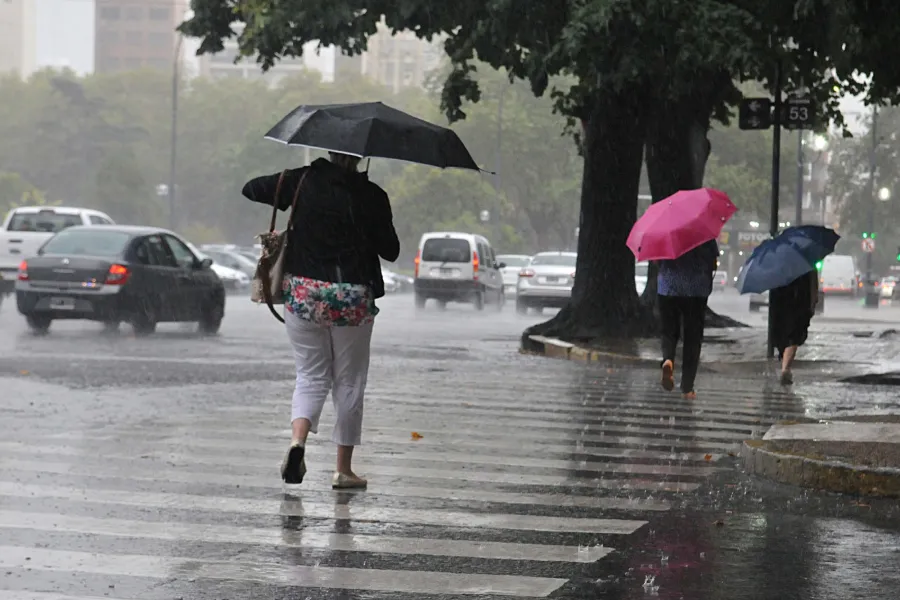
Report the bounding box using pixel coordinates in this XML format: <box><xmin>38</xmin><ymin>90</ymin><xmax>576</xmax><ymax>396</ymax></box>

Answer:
<box><xmin>243</xmin><ymin>153</ymin><xmax>400</xmax><ymax>489</ymax></box>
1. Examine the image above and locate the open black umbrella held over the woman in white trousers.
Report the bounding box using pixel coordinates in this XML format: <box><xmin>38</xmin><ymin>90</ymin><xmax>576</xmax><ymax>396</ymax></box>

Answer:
<box><xmin>265</xmin><ymin>102</ymin><xmax>481</xmax><ymax>171</ymax></box>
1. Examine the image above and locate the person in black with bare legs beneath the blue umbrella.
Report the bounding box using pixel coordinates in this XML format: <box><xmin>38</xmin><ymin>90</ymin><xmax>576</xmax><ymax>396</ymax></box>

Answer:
<box><xmin>769</xmin><ymin>270</ymin><xmax>819</xmax><ymax>385</ymax></box>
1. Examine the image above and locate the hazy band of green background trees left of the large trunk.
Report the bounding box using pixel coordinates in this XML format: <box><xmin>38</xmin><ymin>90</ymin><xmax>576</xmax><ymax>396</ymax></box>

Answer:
<box><xmin>0</xmin><ymin>69</ymin><xmax>581</xmax><ymax>253</ymax></box>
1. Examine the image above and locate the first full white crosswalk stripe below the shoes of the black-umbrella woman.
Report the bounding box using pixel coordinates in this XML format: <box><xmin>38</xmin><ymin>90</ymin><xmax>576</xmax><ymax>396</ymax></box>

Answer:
<box><xmin>0</xmin><ymin>481</ymin><xmax>647</xmax><ymax>534</ymax></box>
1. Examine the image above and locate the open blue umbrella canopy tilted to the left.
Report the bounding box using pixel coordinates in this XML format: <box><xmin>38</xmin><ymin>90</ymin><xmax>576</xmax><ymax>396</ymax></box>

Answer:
<box><xmin>737</xmin><ymin>226</ymin><xmax>840</xmax><ymax>294</ymax></box>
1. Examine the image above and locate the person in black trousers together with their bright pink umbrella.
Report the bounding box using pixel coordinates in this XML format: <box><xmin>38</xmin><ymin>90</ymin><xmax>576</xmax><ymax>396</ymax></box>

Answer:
<box><xmin>626</xmin><ymin>188</ymin><xmax>737</xmax><ymax>400</ymax></box>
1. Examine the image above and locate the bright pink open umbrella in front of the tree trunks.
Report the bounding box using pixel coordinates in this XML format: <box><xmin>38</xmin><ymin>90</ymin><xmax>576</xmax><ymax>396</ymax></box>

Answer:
<box><xmin>625</xmin><ymin>188</ymin><xmax>737</xmax><ymax>260</ymax></box>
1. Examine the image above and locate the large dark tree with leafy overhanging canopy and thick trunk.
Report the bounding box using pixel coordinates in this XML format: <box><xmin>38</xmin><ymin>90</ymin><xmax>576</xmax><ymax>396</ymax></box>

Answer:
<box><xmin>183</xmin><ymin>0</ymin><xmax>900</xmax><ymax>339</ymax></box>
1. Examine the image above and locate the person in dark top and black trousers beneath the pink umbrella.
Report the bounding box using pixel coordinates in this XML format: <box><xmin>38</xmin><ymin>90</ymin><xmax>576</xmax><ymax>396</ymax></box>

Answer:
<box><xmin>657</xmin><ymin>240</ymin><xmax>719</xmax><ymax>400</ymax></box>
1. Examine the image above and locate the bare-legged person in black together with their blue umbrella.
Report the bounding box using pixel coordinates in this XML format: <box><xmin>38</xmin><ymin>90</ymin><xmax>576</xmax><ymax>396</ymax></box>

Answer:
<box><xmin>737</xmin><ymin>225</ymin><xmax>840</xmax><ymax>385</ymax></box>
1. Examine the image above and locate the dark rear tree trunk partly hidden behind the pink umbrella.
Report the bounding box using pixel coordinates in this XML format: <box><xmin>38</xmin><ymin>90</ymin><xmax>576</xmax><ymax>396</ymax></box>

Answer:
<box><xmin>641</xmin><ymin>77</ymin><xmax>746</xmax><ymax>327</ymax></box>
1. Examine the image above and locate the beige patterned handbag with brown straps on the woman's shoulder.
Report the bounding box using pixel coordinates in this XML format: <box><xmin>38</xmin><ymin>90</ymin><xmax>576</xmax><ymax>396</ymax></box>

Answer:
<box><xmin>250</xmin><ymin>170</ymin><xmax>309</xmax><ymax>323</ymax></box>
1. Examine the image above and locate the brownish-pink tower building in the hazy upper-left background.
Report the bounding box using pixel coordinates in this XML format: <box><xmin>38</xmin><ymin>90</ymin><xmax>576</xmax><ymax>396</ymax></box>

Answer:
<box><xmin>94</xmin><ymin>0</ymin><xmax>190</xmax><ymax>73</ymax></box>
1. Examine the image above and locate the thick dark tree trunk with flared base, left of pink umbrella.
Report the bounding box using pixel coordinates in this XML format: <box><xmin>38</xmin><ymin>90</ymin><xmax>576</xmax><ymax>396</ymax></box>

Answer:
<box><xmin>523</xmin><ymin>88</ymin><xmax>657</xmax><ymax>347</ymax></box>
